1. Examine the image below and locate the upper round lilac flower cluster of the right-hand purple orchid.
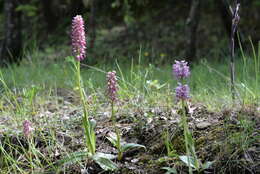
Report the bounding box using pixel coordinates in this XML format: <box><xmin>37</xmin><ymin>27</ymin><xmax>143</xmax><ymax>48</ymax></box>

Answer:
<box><xmin>172</xmin><ymin>60</ymin><xmax>190</xmax><ymax>79</ymax></box>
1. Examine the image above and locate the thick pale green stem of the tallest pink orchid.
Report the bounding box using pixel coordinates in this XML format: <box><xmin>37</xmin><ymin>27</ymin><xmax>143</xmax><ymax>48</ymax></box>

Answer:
<box><xmin>76</xmin><ymin>61</ymin><xmax>96</xmax><ymax>155</ymax></box>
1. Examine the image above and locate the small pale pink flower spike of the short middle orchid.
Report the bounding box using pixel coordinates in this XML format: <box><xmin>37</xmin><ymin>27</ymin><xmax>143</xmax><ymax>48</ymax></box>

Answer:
<box><xmin>107</xmin><ymin>71</ymin><xmax>117</xmax><ymax>102</ymax></box>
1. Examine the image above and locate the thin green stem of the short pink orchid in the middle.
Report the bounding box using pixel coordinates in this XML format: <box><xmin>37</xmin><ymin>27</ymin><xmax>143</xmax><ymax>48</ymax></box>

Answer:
<box><xmin>111</xmin><ymin>101</ymin><xmax>123</xmax><ymax>161</ymax></box>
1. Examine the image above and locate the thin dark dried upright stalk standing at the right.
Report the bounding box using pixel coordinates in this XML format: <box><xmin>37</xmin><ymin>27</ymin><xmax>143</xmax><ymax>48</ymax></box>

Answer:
<box><xmin>230</xmin><ymin>1</ymin><xmax>240</xmax><ymax>103</ymax></box>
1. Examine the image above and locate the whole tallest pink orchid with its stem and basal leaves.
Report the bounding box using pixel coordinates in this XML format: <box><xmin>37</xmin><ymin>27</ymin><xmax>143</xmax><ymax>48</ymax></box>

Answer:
<box><xmin>55</xmin><ymin>15</ymin><xmax>117</xmax><ymax>171</ymax></box>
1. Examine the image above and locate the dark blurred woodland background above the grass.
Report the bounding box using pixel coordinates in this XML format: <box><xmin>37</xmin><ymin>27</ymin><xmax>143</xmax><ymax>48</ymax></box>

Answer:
<box><xmin>0</xmin><ymin>0</ymin><xmax>260</xmax><ymax>65</ymax></box>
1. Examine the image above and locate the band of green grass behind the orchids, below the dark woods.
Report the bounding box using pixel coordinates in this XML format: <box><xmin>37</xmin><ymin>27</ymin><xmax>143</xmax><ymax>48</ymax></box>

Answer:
<box><xmin>2</xmin><ymin>45</ymin><xmax>260</xmax><ymax>108</ymax></box>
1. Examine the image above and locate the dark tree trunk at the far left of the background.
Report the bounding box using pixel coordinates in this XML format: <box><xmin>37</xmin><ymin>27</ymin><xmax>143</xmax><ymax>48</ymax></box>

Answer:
<box><xmin>0</xmin><ymin>0</ymin><xmax>22</xmax><ymax>65</ymax></box>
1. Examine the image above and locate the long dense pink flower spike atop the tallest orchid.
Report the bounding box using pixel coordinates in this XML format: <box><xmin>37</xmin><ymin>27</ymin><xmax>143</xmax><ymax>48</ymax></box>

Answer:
<box><xmin>71</xmin><ymin>15</ymin><xmax>86</xmax><ymax>61</ymax></box>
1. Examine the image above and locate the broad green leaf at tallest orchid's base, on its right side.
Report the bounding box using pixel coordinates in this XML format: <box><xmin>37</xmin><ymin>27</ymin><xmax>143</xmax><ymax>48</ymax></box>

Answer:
<box><xmin>92</xmin><ymin>154</ymin><xmax>117</xmax><ymax>171</ymax></box>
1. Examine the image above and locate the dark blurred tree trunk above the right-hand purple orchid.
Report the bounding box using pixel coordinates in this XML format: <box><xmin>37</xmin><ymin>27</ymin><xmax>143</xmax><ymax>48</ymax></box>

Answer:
<box><xmin>186</xmin><ymin>0</ymin><xmax>200</xmax><ymax>62</ymax></box>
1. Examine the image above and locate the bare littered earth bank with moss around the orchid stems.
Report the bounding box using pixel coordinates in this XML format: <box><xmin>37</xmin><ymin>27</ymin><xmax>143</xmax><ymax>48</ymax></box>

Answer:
<box><xmin>0</xmin><ymin>87</ymin><xmax>260</xmax><ymax>174</ymax></box>
